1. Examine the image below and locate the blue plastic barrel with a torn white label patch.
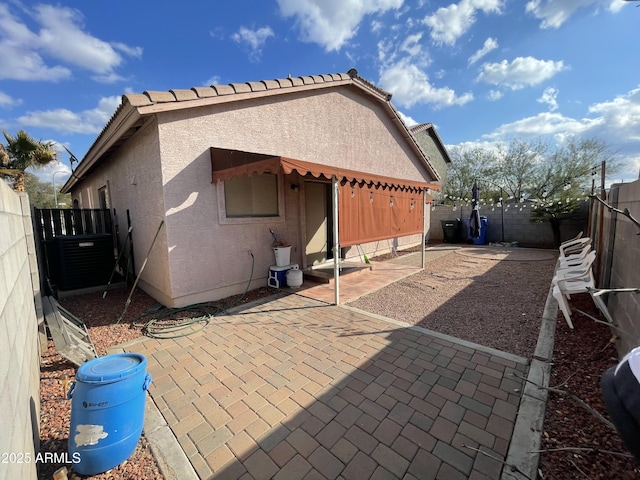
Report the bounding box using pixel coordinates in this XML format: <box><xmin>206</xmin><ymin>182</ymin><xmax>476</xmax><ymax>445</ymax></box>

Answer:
<box><xmin>69</xmin><ymin>353</ymin><xmax>151</xmax><ymax>475</ymax></box>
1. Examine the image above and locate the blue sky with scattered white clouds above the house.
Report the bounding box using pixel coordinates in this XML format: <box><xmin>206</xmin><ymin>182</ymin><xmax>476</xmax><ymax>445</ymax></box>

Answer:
<box><xmin>0</xmin><ymin>0</ymin><xmax>640</xmax><ymax>189</ymax></box>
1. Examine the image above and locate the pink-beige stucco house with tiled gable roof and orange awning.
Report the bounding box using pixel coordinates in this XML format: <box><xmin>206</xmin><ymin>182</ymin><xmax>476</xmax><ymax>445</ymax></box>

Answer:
<box><xmin>62</xmin><ymin>69</ymin><xmax>447</xmax><ymax>307</ymax></box>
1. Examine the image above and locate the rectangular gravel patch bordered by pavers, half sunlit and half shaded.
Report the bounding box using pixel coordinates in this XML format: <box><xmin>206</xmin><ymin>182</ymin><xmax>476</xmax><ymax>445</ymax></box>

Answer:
<box><xmin>350</xmin><ymin>251</ymin><xmax>555</xmax><ymax>357</ymax></box>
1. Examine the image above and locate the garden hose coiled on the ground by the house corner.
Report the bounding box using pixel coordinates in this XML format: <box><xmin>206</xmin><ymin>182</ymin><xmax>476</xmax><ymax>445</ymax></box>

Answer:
<box><xmin>133</xmin><ymin>253</ymin><xmax>255</xmax><ymax>339</ymax></box>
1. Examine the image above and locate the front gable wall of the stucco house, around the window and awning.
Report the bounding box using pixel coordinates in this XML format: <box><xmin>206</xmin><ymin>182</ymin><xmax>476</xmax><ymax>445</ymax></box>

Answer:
<box><xmin>158</xmin><ymin>87</ymin><xmax>431</xmax><ymax>305</ymax></box>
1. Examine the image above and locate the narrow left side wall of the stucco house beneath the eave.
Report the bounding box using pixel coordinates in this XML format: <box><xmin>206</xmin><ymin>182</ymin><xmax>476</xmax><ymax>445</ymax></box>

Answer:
<box><xmin>74</xmin><ymin>120</ymin><xmax>172</xmax><ymax>305</ymax></box>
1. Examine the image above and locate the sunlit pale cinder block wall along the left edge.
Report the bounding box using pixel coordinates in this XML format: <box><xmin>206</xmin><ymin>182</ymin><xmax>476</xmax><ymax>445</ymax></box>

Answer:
<box><xmin>0</xmin><ymin>181</ymin><xmax>41</xmax><ymax>479</ymax></box>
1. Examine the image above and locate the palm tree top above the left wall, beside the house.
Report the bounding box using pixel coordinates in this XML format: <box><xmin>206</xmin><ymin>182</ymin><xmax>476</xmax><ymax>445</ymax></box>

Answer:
<box><xmin>0</xmin><ymin>130</ymin><xmax>57</xmax><ymax>192</ymax></box>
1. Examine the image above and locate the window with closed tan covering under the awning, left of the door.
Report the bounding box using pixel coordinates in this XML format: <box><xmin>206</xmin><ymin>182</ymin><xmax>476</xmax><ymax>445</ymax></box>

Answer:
<box><xmin>224</xmin><ymin>173</ymin><xmax>279</xmax><ymax>218</ymax></box>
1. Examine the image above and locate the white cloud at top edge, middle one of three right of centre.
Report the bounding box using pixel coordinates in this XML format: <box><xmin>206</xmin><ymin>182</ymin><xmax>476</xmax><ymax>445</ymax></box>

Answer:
<box><xmin>423</xmin><ymin>0</ymin><xmax>503</xmax><ymax>45</ymax></box>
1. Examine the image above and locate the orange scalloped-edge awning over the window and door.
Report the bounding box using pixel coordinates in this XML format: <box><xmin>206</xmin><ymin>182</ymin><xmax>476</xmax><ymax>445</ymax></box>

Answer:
<box><xmin>210</xmin><ymin>147</ymin><xmax>440</xmax><ymax>191</ymax></box>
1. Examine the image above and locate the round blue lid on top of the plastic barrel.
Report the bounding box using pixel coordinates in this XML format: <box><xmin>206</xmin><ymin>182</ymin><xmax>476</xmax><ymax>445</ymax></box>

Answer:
<box><xmin>76</xmin><ymin>353</ymin><xmax>147</xmax><ymax>383</ymax></box>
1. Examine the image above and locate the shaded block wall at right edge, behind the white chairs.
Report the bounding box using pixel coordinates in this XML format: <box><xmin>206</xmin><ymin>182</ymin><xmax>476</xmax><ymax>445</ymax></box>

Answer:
<box><xmin>599</xmin><ymin>180</ymin><xmax>640</xmax><ymax>356</ymax></box>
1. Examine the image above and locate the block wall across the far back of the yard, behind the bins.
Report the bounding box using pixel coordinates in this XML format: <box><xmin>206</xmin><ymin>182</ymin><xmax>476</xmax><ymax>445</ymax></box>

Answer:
<box><xmin>429</xmin><ymin>204</ymin><xmax>587</xmax><ymax>248</ymax></box>
